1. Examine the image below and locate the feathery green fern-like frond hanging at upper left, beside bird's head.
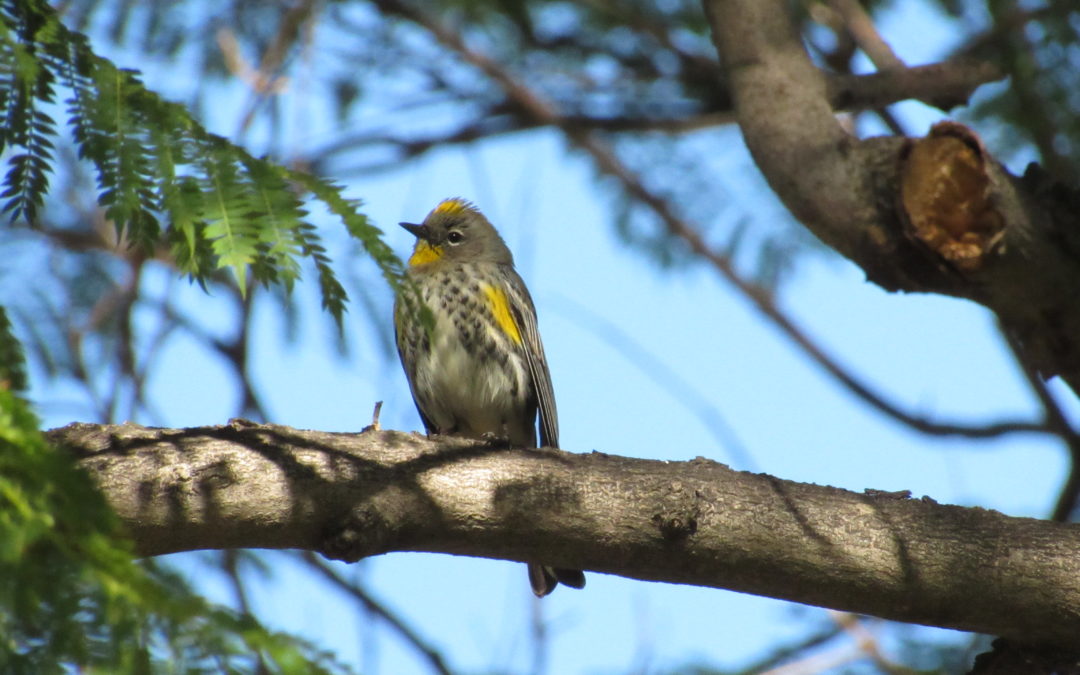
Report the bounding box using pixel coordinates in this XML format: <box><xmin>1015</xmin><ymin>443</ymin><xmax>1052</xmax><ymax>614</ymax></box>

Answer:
<box><xmin>0</xmin><ymin>1</ymin><xmax>401</xmax><ymax>325</ymax></box>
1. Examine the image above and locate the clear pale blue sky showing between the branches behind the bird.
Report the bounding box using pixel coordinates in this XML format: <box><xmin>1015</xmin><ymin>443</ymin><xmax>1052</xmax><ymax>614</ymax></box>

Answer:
<box><xmin>19</xmin><ymin>2</ymin><xmax>1077</xmax><ymax>673</ymax></box>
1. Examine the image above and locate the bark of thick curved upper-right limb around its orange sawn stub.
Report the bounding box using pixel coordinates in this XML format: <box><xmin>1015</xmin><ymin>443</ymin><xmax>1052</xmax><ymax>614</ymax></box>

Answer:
<box><xmin>704</xmin><ymin>0</ymin><xmax>1080</xmax><ymax>392</ymax></box>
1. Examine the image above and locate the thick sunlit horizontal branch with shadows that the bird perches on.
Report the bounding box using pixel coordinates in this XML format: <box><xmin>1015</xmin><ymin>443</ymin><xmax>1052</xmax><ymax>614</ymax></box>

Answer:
<box><xmin>49</xmin><ymin>420</ymin><xmax>1080</xmax><ymax>648</ymax></box>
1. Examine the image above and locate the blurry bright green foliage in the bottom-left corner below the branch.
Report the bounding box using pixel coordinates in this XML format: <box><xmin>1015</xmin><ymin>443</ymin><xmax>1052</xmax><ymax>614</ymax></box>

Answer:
<box><xmin>0</xmin><ymin>389</ymin><xmax>354</xmax><ymax>673</ymax></box>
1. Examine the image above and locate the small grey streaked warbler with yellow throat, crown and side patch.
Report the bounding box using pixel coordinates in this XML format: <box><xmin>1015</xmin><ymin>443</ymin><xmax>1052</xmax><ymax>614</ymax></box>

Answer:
<box><xmin>394</xmin><ymin>198</ymin><xmax>585</xmax><ymax>597</ymax></box>
